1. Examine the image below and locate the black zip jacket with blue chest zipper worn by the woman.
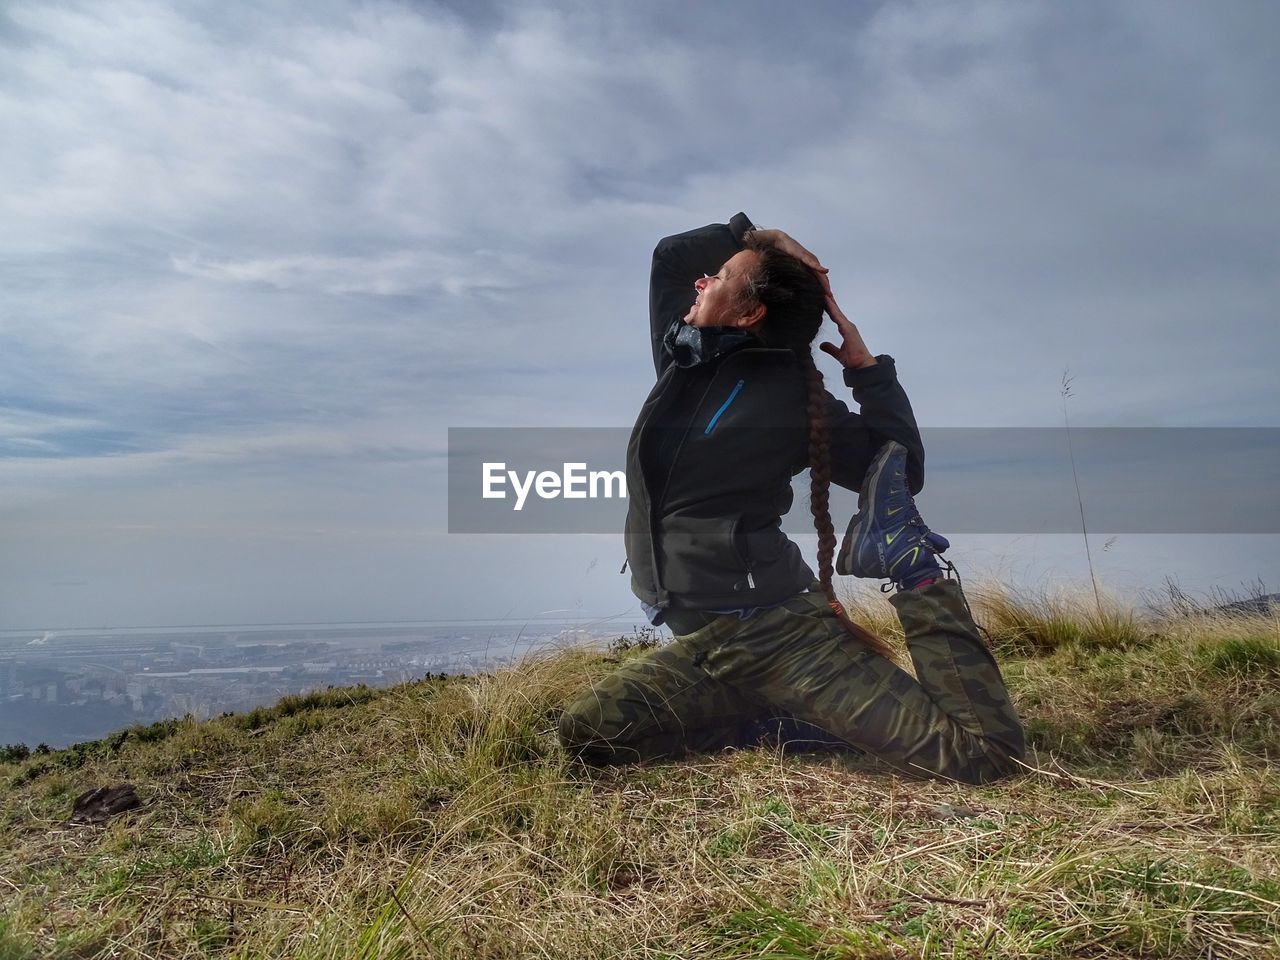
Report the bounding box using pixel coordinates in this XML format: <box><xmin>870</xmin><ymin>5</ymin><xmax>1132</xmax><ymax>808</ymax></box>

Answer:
<box><xmin>625</xmin><ymin>214</ymin><xmax>924</xmax><ymax>609</ymax></box>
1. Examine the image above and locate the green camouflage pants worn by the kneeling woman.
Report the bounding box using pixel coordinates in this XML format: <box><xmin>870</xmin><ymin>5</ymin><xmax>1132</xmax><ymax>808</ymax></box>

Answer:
<box><xmin>559</xmin><ymin>580</ymin><xmax>1025</xmax><ymax>783</ymax></box>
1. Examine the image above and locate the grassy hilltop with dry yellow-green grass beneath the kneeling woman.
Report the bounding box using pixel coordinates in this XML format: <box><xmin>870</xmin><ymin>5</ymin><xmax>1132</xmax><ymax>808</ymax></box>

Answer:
<box><xmin>0</xmin><ymin>589</ymin><xmax>1280</xmax><ymax>960</ymax></box>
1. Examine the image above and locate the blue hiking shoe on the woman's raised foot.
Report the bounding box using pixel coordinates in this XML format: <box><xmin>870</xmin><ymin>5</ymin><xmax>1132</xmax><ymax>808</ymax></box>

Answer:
<box><xmin>836</xmin><ymin>440</ymin><xmax>951</xmax><ymax>590</ymax></box>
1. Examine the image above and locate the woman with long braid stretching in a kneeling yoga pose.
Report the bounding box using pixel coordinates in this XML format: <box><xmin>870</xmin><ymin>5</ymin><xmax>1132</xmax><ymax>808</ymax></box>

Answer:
<box><xmin>559</xmin><ymin>214</ymin><xmax>1024</xmax><ymax>783</ymax></box>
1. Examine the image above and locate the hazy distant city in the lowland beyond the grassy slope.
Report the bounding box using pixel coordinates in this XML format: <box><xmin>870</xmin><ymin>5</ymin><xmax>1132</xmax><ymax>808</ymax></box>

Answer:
<box><xmin>0</xmin><ymin>621</ymin><xmax>634</xmax><ymax>748</ymax></box>
